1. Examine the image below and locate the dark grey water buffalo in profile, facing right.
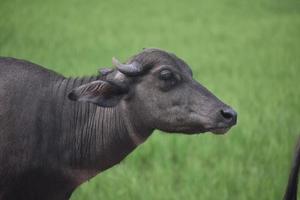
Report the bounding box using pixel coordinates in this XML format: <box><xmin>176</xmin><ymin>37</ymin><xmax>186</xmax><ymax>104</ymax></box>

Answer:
<box><xmin>0</xmin><ymin>49</ymin><xmax>236</xmax><ymax>200</ymax></box>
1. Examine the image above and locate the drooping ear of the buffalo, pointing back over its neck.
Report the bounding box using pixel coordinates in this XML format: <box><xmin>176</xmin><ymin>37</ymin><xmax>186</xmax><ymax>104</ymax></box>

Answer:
<box><xmin>68</xmin><ymin>80</ymin><xmax>126</xmax><ymax>107</ymax></box>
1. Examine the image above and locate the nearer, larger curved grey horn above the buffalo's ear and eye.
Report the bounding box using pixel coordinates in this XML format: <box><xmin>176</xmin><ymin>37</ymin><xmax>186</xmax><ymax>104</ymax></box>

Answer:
<box><xmin>112</xmin><ymin>57</ymin><xmax>143</xmax><ymax>76</ymax></box>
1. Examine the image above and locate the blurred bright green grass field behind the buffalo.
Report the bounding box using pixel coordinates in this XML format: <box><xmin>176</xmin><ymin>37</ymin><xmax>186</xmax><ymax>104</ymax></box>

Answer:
<box><xmin>0</xmin><ymin>0</ymin><xmax>300</xmax><ymax>200</ymax></box>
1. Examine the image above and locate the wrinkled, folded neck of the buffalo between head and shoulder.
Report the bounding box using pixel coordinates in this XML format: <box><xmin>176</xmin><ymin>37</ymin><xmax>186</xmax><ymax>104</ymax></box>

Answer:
<box><xmin>52</xmin><ymin>77</ymin><xmax>153</xmax><ymax>185</ymax></box>
